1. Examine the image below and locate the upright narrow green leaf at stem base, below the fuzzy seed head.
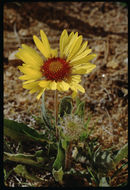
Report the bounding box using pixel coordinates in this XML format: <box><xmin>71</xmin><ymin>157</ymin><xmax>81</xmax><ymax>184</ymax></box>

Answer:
<box><xmin>53</xmin><ymin>141</ymin><xmax>65</xmax><ymax>170</ymax></box>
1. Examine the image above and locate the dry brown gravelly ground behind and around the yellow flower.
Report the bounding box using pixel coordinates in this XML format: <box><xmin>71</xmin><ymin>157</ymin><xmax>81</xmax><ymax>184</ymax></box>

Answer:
<box><xmin>4</xmin><ymin>2</ymin><xmax>128</xmax><ymax>187</ymax></box>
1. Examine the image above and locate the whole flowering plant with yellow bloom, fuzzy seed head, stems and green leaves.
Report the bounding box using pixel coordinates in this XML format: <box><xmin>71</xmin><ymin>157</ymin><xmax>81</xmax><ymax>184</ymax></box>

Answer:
<box><xmin>4</xmin><ymin>30</ymin><xmax>128</xmax><ymax>186</ymax></box>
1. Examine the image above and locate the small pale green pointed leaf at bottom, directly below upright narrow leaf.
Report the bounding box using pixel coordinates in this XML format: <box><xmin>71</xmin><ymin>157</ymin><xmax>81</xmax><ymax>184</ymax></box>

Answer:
<box><xmin>52</xmin><ymin>167</ymin><xmax>64</xmax><ymax>184</ymax></box>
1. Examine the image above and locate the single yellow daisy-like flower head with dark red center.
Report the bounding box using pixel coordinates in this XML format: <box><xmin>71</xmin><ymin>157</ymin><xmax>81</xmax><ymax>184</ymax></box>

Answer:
<box><xmin>16</xmin><ymin>30</ymin><xmax>96</xmax><ymax>99</ymax></box>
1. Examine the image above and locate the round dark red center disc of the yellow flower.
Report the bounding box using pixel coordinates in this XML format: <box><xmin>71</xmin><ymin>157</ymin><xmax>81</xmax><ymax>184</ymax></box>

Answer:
<box><xmin>41</xmin><ymin>57</ymin><xmax>71</xmax><ymax>81</ymax></box>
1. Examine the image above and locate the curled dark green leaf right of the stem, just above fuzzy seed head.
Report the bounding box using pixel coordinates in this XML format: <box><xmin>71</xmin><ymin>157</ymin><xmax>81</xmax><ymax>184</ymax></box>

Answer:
<box><xmin>59</xmin><ymin>96</ymin><xmax>72</xmax><ymax>117</ymax></box>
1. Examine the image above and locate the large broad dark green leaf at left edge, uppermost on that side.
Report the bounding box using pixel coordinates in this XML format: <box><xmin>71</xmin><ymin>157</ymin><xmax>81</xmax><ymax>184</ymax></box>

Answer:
<box><xmin>4</xmin><ymin>119</ymin><xmax>51</xmax><ymax>143</ymax></box>
